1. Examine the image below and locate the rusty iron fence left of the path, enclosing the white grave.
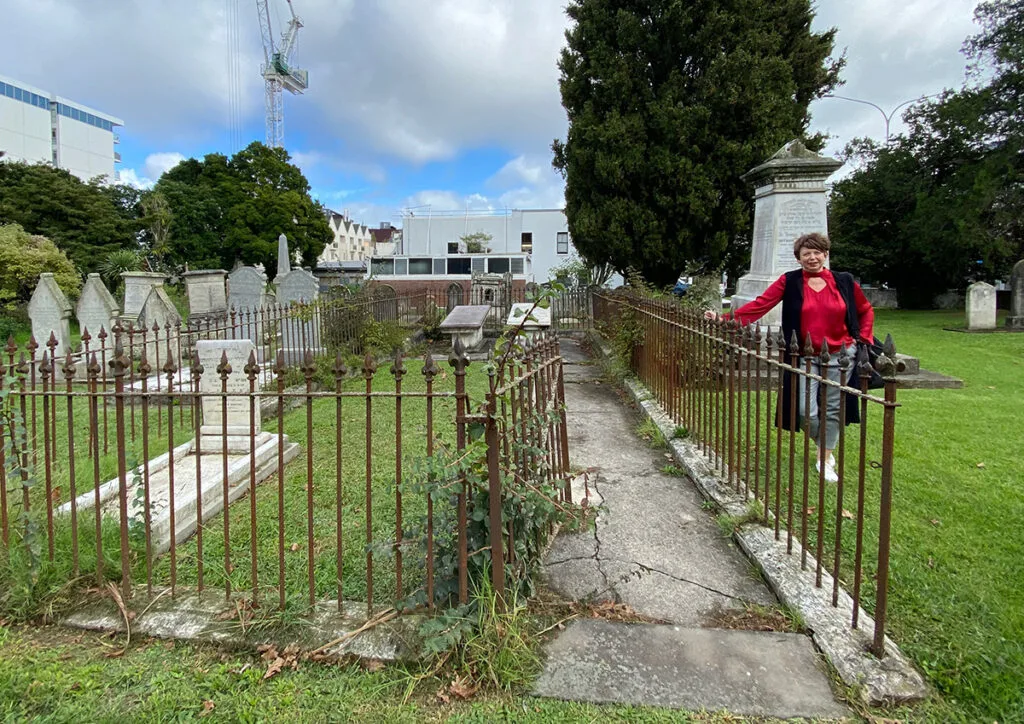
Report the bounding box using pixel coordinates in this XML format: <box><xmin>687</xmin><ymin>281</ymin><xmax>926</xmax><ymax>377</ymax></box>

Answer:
<box><xmin>0</xmin><ymin>295</ymin><xmax>570</xmax><ymax>614</ymax></box>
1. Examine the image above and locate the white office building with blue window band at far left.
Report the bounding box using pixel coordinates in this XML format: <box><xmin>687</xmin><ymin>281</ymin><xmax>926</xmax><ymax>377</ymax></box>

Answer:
<box><xmin>0</xmin><ymin>76</ymin><xmax>124</xmax><ymax>181</ymax></box>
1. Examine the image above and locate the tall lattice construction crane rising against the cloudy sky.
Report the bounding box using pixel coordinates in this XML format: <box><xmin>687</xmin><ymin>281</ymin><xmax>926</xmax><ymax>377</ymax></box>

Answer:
<box><xmin>256</xmin><ymin>0</ymin><xmax>309</xmax><ymax>148</ymax></box>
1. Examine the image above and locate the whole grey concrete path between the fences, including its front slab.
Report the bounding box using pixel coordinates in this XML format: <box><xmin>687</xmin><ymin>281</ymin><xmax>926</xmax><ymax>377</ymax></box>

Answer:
<box><xmin>535</xmin><ymin>340</ymin><xmax>850</xmax><ymax>719</ymax></box>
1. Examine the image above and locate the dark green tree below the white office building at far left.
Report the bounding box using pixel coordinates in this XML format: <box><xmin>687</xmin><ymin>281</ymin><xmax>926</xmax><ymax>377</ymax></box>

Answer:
<box><xmin>0</xmin><ymin>163</ymin><xmax>138</xmax><ymax>272</ymax></box>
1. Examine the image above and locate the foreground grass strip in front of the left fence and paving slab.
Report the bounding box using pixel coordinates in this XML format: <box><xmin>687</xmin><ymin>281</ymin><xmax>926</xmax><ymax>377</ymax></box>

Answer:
<box><xmin>0</xmin><ymin>627</ymin><xmax>782</xmax><ymax>724</ymax></box>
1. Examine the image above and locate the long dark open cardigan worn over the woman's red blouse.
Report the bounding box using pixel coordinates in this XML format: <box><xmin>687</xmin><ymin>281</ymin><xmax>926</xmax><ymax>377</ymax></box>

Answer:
<box><xmin>775</xmin><ymin>269</ymin><xmax>860</xmax><ymax>432</ymax></box>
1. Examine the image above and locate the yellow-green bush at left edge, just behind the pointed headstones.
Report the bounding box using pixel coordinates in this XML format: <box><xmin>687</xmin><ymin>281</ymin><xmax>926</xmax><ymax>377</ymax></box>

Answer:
<box><xmin>0</xmin><ymin>223</ymin><xmax>82</xmax><ymax>309</ymax></box>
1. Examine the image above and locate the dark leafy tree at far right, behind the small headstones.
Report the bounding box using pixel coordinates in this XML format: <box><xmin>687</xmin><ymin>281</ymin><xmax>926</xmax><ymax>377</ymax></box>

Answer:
<box><xmin>829</xmin><ymin>0</ymin><xmax>1024</xmax><ymax>307</ymax></box>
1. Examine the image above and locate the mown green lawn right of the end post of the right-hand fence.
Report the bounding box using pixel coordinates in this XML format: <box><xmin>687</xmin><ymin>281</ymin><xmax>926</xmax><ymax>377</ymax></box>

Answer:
<box><xmin>876</xmin><ymin>310</ymin><xmax>1024</xmax><ymax>722</ymax></box>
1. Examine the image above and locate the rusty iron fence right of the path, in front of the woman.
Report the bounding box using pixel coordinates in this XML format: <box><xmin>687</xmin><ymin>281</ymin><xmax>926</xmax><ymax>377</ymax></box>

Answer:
<box><xmin>594</xmin><ymin>292</ymin><xmax>898</xmax><ymax>656</ymax></box>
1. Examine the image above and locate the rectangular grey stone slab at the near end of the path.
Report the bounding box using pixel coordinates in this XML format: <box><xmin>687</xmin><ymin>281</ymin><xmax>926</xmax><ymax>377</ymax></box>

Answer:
<box><xmin>534</xmin><ymin>620</ymin><xmax>850</xmax><ymax>719</ymax></box>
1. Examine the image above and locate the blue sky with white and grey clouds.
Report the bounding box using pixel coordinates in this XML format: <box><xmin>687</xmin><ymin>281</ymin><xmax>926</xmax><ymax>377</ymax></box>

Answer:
<box><xmin>0</xmin><ymin>0</ymin><xmax>975</xmax><ymax>225</ymax></box>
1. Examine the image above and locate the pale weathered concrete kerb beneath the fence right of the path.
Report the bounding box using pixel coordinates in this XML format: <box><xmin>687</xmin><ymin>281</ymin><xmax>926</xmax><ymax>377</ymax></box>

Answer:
<box><xmin>591</xmin><ymin>335</ymin><xmax>930</xmax><ymax>707</ymax></box>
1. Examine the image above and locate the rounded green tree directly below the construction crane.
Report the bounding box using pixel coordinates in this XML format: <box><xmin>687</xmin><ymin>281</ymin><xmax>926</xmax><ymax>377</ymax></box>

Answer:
<box><xmin>153</xmin><ymin>142</ymin><xmax>332</xmax><ymax>273</ymax></box>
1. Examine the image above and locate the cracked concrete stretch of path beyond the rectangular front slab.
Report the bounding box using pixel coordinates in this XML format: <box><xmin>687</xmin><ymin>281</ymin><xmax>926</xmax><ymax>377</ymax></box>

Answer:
<box><xmin>545</xmin><ymin>342</ymin><xmax>775</xmax><ymax>627</ymax></box>
